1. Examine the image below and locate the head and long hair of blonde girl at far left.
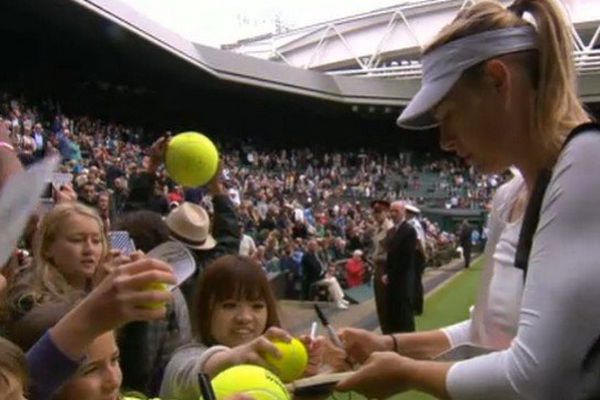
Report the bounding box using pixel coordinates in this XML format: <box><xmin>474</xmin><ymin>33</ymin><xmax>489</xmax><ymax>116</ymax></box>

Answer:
<box><xmin>8</xmin><ymin>202</ymin><xmax>108</xmax><ymax>318</ymax></box>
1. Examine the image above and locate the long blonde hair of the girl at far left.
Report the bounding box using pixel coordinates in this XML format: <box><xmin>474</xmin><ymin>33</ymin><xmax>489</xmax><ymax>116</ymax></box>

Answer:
<box><xmin>8</xmin><ymin>203</ymin><xmax>108</xmax><ymax>315</ymax></box>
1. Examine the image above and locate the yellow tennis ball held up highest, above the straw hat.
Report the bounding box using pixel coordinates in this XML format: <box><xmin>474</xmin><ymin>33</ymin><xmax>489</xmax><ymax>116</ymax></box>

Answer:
<box><xmin>165</xmin><ymin>132</ymin><xmax>219</xmax><ymax>187</ymax></box>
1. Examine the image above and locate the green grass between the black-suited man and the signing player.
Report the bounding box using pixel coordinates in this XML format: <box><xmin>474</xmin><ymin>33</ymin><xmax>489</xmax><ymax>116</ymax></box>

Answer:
<box><xmin>330</xmin><ymin>258</ymin><xmax>483</xmax><ymax>400</ymax></box>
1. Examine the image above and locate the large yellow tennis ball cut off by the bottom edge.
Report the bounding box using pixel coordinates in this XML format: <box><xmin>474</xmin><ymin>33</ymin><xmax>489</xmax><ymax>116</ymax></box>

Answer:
<box><xmin>211</xmin><ymin>365</ymin><xmax>291</xmax><ymax>400</ymax></box>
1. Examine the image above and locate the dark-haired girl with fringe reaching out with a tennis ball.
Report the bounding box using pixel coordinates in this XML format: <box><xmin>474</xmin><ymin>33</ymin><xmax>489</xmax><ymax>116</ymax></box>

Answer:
<box><xmin>160</xmin><ymin>255</ymin><xmax>323</xmax><ymax>400</ymax></box>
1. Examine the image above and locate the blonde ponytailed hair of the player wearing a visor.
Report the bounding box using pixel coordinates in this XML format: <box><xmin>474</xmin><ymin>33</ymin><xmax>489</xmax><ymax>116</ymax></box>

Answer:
<box><xmin>424</xmin><ymin>0</ymin><xmax>589</xmax><ymax>162</ymax></box>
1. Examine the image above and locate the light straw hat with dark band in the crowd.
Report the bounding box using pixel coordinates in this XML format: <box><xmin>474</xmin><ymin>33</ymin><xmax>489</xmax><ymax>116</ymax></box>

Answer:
<box><xmin>165</xmin><ymin>202</ymin><xmax>217</xmax><ymax>250</ymax></box>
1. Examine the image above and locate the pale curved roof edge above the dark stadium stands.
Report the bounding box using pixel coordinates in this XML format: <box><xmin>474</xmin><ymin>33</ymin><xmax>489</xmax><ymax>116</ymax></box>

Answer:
<box><xmin>65</xmin><ymin>0</ymin><xmax>414</xmax><ymax>106</ymax></box>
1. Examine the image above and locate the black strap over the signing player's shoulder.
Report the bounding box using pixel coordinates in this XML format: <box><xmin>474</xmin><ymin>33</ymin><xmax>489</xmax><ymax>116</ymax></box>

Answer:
<box><xmin>515</xmin><ymin>122</ymin><xmax>600</xmax><ymax>280</ymax></box>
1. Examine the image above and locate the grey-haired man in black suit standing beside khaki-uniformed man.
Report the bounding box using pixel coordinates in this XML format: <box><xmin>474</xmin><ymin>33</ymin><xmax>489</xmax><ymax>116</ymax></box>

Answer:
<box><xmin>381</xmin><ymin>201</ymin><xmax>417</xmax><ymax>334</ymax></box>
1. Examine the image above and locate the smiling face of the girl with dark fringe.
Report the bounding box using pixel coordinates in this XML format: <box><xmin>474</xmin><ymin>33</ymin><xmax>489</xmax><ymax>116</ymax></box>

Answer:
<box><xmin>211</xmin><ymin>299</ymin><xmax>268</xmax><ymax>347</ymax></box>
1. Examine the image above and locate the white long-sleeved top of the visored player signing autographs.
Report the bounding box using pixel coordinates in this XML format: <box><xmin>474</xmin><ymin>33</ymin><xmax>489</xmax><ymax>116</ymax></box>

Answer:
<box><xmin>446</xmin><ymin>132</ymin><xmax>600</xmax><ymax>400</ymax></box>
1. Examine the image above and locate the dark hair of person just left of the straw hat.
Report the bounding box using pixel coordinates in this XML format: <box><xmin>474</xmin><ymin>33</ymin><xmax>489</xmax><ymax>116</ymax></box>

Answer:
<box><xmin>114</xmin><ymin>210</ymin><xmax>170</xmax><ymax>253</ymax></box>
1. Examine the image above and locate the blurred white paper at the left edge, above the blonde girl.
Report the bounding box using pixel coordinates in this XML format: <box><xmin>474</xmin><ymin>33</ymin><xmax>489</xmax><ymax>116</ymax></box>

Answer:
<box><xmin>0</xmin><ymin>156</ymin><xmax>59</xmax><ymax>268</ymax></box>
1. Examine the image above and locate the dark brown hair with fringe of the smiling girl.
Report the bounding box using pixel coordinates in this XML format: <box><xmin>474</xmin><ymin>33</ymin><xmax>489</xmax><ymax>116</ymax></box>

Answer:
<box><xmin>192</xmin><ymin>255</ymin><xmax>281</xmax><ymax>346</ymax></box>
